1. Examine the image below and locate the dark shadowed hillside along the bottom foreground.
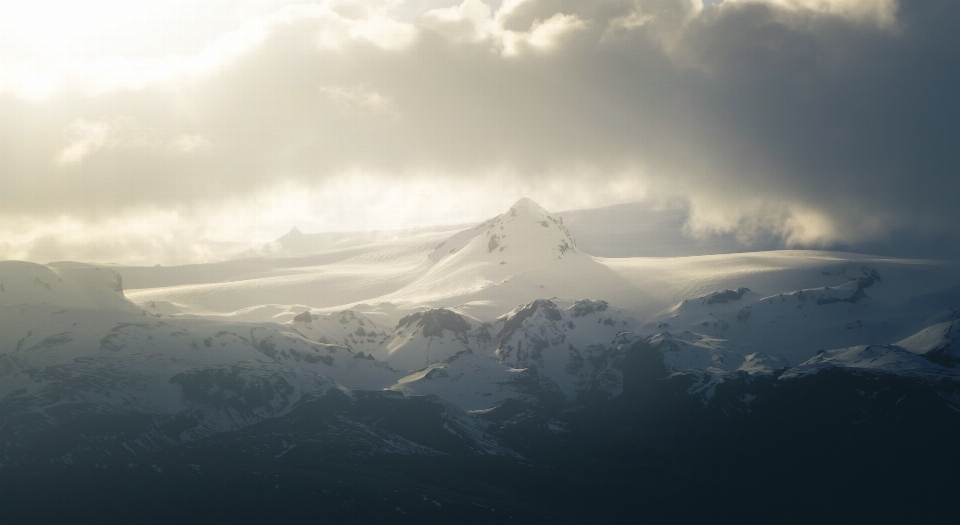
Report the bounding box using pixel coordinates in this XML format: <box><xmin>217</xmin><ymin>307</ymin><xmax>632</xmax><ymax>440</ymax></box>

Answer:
<box><xmin>7</xmin><ymin>342</ymin><xmax>960</xmax><ymax>524</ymax></box>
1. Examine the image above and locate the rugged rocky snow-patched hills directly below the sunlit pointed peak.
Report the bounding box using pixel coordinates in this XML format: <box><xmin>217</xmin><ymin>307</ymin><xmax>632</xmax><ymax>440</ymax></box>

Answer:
<box><xmin>392</xmin><ymin>299</ymin><xmax>636</xmax><ymax>410</ymax></box>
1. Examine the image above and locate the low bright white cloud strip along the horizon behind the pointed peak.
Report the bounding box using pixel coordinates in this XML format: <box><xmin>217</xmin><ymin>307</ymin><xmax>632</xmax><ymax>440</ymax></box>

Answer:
<box><xmin>0</xmin><ymin>166</ymin><xmax>645</xmax><ymax>265</ymax></box>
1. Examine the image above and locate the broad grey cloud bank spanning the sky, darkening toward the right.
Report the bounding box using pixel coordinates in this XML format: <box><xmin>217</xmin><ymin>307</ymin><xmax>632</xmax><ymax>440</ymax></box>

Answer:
<box><xmin>0</xmin><ymin>0</ymin><xmax>960</xmax><ymax>260</ymax></box>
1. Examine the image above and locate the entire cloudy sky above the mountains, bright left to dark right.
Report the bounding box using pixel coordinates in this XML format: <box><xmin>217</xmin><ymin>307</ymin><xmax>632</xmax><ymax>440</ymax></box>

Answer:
<box><xmin>0</xmin><ymin>0</ymin><xmax>960</xmax><ymax>264</ymax></box>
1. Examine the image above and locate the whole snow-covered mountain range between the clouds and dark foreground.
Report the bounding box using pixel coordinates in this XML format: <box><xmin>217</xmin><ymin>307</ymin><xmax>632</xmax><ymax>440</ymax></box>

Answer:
<box><xmin>0</xmin><ymin>199</ymin><xmax>960</xmax><ymax>474</ymax></box>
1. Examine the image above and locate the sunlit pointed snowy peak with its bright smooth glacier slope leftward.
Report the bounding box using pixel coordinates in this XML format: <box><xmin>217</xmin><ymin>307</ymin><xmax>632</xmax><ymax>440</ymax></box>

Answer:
<box><xmin>116</xmin><ymin>199</ymin><xmax>638</xmax><ymax>322</ymax></box>
